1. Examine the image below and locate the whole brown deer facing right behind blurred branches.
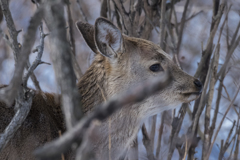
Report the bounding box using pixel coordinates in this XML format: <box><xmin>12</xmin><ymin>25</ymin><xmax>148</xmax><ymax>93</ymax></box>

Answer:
<box><xmin>0</xmin><ymin>17</ymin><xmax>202</xmax><ymax>160</ymax></box>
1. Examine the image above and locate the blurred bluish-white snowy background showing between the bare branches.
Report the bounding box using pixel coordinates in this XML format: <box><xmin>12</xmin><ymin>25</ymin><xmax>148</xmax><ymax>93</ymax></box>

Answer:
<box><xmin>0</xmin><ymin>0</ymin><xmax>240</xmax><ymax>159</ymax></box>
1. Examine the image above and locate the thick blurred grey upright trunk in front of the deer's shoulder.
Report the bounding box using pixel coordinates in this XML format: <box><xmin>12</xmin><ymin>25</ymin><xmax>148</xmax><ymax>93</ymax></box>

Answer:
<box><xmin>42</xmin><ymin>2</ymin><xmax>82</xmax><ymax>129</ymax></box>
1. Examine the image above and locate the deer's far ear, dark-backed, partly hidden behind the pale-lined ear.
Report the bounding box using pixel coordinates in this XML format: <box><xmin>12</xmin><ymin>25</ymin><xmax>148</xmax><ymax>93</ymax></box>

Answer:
<box><xmin>76</xmin><ymin>21</ymin><xmax>98</xmax><ymax>53</ymax></box>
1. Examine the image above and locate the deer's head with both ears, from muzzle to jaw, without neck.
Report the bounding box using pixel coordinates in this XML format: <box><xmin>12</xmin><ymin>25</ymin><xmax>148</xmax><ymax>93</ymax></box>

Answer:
<box><xmin>77</xmin><ymin>18</ymin><xmax>202</xmax><ymax>117</ymax></box>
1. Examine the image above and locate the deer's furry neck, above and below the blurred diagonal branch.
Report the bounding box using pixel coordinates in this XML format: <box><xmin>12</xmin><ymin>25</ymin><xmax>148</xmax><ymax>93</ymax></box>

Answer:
<box><xmin>78</xmin><ymin>55</ymin><xmax>141</xmax><ymax>157</ymax></box>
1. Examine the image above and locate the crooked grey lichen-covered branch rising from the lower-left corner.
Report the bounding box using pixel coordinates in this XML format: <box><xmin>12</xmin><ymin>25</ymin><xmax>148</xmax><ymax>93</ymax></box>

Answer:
<box><xmin>0</xmin><ymin>12</ymin><xmax>46</xmax><ymax>152</ymax></box>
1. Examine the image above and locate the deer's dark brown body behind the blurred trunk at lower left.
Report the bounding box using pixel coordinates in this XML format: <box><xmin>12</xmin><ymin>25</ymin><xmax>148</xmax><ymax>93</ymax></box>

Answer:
<box><xmin>0</xmin><ymin>87</ymin><xmax>65</xmax><ymax>160</ymax></box>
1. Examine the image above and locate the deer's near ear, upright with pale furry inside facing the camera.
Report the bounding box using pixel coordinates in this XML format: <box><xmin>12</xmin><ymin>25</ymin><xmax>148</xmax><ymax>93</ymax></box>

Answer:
<box><xmin>94</xmin><ymin>18</ymin><xmax>123</xmax><ymax>58</ymax></box>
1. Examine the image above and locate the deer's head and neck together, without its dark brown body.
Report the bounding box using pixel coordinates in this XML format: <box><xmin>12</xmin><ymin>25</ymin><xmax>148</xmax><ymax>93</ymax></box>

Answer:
<box><xmin>76</xmin><ymin>18</ymin><xmax>202</xmax><ymax>159</ymax></box>
